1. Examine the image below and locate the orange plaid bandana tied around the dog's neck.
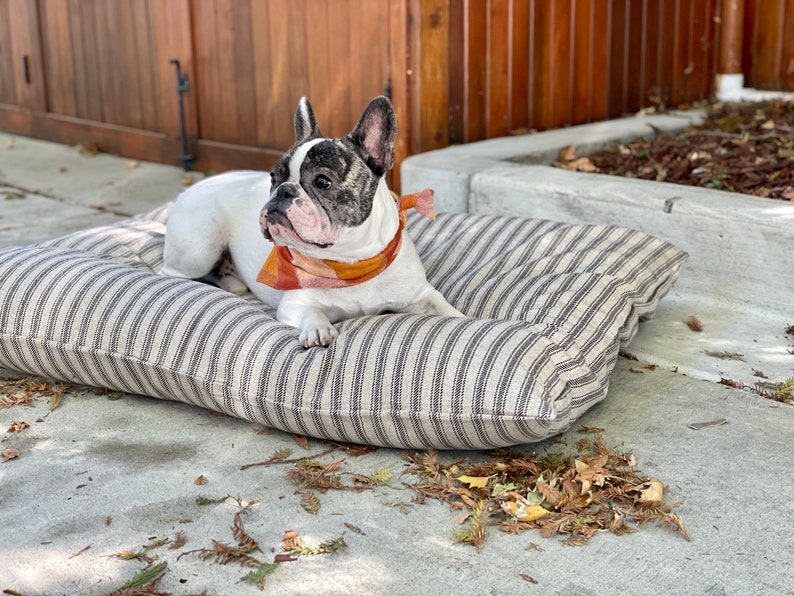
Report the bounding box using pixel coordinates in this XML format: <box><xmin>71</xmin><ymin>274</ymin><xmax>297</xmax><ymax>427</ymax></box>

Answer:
<box><xmin>256</xmin><ymin>189</ymin><xmax>436</xmax><ymax>290</ymax></box>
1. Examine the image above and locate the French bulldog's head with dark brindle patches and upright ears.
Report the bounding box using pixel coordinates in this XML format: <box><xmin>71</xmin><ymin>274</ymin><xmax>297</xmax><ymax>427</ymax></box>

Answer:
<box><xmin>260</xmin><ymin>97</ymin><xmax>397</xmax><ymax>252</ymax></box>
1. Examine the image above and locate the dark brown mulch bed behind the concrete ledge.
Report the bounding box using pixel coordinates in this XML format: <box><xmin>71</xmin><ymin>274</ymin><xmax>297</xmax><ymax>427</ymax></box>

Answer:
<box><xmin>555</xmin><ymin>100</ymin><xmax>794</xmax><ymax>201</ymax></box>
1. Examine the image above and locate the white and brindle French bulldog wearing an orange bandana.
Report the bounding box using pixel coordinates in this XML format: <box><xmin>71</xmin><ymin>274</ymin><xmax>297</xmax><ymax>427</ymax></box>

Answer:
<box><xmin>160</xmin><ymin>97</ymin><xmax>463</xmax><ymax>348</ymax></box>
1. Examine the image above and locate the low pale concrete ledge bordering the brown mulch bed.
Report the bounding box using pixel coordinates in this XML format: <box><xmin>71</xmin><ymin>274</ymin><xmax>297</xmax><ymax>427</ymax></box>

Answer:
<box><xmin>402</xmin><ymin>112</ymin><xmax>794</xmax><ymax>309</ymax></box>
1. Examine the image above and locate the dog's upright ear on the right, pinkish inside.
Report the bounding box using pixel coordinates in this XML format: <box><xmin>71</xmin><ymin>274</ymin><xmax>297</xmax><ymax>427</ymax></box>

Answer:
<box><xmin>348</xmin><ymin>96</ymin><xmax>397</xmax><ymax>176</ymax></box>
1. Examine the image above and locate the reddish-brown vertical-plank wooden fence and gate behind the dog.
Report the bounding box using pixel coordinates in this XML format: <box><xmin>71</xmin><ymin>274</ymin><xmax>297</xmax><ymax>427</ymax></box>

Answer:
<box><xmin>0</xmin><ymin>0</ymin><xmax>794</xmax><ymax>184</ymax></box>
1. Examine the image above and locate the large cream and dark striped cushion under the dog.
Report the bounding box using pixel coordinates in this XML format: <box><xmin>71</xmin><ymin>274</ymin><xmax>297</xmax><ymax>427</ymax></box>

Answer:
<box><xmin>0</xmin><ymin>207</ymin><xmax>686</xmax><ymax>449</ymax></box>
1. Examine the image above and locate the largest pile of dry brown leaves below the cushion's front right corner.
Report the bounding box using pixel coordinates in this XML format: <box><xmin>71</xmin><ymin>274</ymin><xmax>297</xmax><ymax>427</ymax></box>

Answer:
<box><xmin>406</xmin><ymin>435</ymin><xmax>688</xmax><ymax>547</ymax></box>
